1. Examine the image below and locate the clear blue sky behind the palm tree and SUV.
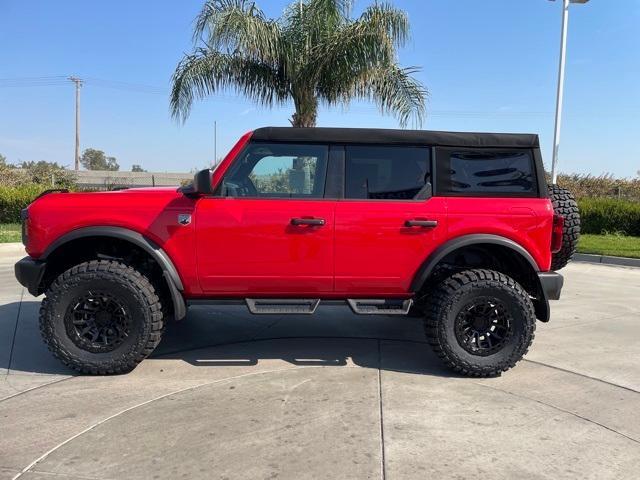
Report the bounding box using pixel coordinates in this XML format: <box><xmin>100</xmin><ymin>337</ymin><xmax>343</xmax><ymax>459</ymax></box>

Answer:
<box><xmin>0</xmin><ymin>0</ymin><xmax>640</xmax><ymax>177</ymax></box>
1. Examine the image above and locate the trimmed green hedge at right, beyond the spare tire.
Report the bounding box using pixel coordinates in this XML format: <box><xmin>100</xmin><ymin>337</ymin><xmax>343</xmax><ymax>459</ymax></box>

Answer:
<box><xmin>578</xmin><ymin>198</ymin><xmax>640</xmax><ymax>237</ymax></box>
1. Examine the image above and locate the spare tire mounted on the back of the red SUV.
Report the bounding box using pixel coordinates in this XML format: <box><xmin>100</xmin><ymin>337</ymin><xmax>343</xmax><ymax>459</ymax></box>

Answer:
<box><xmin>549</xmin><ymin>185</ymin><xmax>580</xmax><ymax>270</ymax></box>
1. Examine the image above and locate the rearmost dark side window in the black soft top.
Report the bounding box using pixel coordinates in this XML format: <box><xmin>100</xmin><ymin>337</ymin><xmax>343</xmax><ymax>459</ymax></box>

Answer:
<box><xmin>436</xmin><ymin>148</ymin><xmax>538</xmax><ymax>197</ymax></box>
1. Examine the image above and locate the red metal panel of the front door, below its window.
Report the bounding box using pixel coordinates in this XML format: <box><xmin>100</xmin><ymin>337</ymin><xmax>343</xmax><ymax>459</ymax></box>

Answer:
<box><xmin>196</xmin><ymin>197</ymin><xmax>335</xmax><ymax>296</ymax></box>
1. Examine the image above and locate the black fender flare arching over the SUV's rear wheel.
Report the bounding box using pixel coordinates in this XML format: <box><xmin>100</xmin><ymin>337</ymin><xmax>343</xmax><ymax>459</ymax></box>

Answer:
<box><xmin>411</xmin><ymin>234</ymin><xmax>550</xmax><ymax>322</ymax></box>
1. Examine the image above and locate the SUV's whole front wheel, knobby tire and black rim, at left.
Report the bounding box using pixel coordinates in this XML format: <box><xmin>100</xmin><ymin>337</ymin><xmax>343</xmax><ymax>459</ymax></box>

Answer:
<box><xmin>40</xmin><ymin>260</ymin><xmax>163</xmax><ymax>375</ymax></box>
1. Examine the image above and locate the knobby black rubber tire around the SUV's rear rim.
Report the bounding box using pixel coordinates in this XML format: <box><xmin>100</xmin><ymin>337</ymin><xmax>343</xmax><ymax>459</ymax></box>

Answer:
<box><xmin>424</xmin><ymin>269</ymin><xmax>536</xmax><ymax>377</ymax></box>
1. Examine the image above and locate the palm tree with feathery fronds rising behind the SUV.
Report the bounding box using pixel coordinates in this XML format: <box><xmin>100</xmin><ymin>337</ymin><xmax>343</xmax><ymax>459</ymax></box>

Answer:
<box><xmin>171</xmin><ymin>0</ymin><xmax>427</xmax><ymax>127</ymax></box>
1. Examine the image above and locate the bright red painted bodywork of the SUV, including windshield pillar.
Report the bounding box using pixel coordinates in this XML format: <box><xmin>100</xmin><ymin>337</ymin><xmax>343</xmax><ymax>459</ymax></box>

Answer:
<box><xmin>26</xmin><ymin>132</ymin><xmax>553</xmax><ymax>298</ymax></box>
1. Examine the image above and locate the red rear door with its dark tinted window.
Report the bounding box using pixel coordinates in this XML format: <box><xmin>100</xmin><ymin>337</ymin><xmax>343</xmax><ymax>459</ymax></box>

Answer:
<box><xmin>335</xmin><ymin>145</ymin><xmax>447</xmax><ymax>297</ymax></box>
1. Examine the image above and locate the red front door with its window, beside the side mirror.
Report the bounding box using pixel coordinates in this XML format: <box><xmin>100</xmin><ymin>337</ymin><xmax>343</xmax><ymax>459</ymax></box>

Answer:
<box><xmin>196</xmin><ymin>143</ymin><xmax>335</xmax><ymax>297</ymax></box>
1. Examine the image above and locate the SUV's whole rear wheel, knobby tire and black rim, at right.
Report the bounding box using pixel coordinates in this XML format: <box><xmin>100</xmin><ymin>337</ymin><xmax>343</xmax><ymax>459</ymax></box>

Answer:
<box><xmin>425</xmin><ymin>270</ymin><xmax>536</xmax><ymax>377</ymax></box>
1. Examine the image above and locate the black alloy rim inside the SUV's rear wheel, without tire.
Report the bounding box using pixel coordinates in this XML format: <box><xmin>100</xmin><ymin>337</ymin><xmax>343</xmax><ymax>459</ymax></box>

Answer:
<box><xmin>455</xmin><ymin>297</ymin><xmax>513</xmax><ymax>357</ymax></box>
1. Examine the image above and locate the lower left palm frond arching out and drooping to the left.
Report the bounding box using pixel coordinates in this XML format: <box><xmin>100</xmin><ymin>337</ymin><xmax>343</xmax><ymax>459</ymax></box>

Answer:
<box><xmin>170</xmin><ymin>49</ymin><xmax>288</xmax><ymax>121</ymax></box>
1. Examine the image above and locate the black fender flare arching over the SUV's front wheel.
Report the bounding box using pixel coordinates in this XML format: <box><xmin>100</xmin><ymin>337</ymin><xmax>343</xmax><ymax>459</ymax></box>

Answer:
<box><xmin>39</xmin><ymin>226</ymin><xmax>187</xmax><ymax>320</ymax></box>
